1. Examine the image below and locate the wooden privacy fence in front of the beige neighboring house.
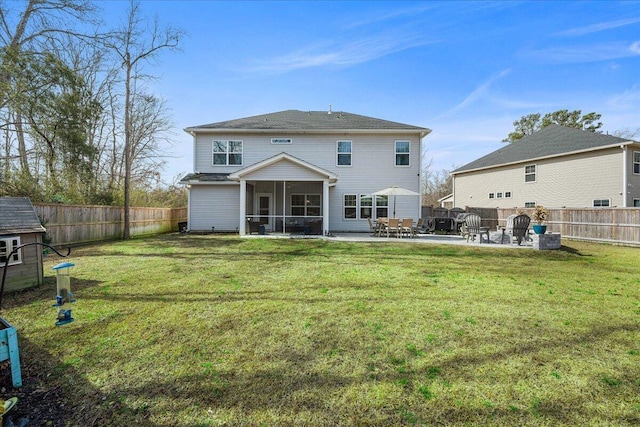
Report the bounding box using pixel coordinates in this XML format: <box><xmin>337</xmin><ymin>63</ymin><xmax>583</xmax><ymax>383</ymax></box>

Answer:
<box><xmin>497</xmin><ymin>208</ymin><xmax>640</xmax><ymax>246</ymax></box>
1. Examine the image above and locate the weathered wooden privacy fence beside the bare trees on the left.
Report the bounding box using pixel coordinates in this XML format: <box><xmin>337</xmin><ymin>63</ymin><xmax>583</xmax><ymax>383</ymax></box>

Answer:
<box><xmin>33</xmin><ymin>203</ymin><xmax>187</xmax><ymax>245</ymax></box>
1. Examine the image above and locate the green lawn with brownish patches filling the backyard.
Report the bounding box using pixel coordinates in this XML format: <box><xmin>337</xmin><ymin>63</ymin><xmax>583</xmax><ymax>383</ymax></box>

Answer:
<box><xmin>3</xmin><ymin>234</ymin><xmax>640</xmax><ymax>427</ymax></box>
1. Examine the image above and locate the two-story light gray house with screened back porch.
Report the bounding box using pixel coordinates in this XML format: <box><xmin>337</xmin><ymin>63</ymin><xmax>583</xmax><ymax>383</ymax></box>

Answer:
<box><xmin>181</xmin><ymin>110</ymin><xmax>431</xmax><ymax>234</ymax></box>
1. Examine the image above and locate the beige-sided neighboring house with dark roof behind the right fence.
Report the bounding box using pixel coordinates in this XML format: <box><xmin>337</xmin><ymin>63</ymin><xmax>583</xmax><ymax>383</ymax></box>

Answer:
<box><xmin>451</xmin><ymin>125</ymin><xmax>640</xmax><ymax>208</ymax></box>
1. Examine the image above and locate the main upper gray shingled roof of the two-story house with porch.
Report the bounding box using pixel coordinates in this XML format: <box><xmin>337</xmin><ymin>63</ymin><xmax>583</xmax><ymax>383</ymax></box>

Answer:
<box><xmin>185</xmin><ymin>110</ymin><xmax>431</xmax><ymax>133</ymax></box>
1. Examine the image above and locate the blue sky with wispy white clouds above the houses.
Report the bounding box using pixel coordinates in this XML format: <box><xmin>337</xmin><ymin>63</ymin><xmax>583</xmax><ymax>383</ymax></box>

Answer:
<box><xmin>99</xmin><ymin>0</ymin><xmax>640</xmax><ymax>185</ymax></box>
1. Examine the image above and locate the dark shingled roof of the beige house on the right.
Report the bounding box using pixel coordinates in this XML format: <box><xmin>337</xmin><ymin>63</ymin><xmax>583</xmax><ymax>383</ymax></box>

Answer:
<box><xmin>452</xmin><ymin>125</ymin><xmax>630</xmax><ymax>174</ymax></box>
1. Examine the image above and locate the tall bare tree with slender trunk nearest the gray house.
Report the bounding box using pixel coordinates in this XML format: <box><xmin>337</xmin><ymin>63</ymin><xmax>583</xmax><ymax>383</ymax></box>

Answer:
<box><xmin>111</xmin><ymin>0</ymin><xmax>182</xmax><ymax>239</ymax></box>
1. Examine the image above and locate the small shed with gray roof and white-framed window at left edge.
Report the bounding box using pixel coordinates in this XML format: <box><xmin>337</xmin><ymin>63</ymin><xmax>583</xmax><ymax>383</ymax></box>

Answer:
<box><xmin>0</xmin><ymin>197</ymin><xmax>47</xmax><ymax>291</ymax></box>
